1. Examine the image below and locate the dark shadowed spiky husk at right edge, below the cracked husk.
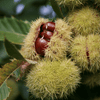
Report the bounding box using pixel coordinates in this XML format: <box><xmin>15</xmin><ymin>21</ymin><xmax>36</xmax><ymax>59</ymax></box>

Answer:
<box><xmin>82</xmin><ymin>72</ymin><xmax>100</xmax><ymax>88</ymax></box>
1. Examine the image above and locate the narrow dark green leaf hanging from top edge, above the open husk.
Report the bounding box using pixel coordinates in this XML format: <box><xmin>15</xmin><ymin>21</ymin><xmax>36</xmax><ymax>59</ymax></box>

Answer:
<box><xmin>50</xmin><ymin>0</ymin><xmax>64</xmax><ymax>19</ymax></box>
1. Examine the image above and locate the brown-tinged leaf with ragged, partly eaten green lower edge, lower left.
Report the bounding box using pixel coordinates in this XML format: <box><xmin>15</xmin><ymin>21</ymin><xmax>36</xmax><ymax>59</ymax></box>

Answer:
<box><xmin>0</xmin><ymin>60</ymin><xmax>30</xmax><ymax>100</ymax></box>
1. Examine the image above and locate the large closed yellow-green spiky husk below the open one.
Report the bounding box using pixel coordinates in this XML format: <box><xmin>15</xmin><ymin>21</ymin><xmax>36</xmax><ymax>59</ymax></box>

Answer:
<box><xmin>26</xmin><ymin>59</ymin><xmax>80</xmax><ymax>99</ymax></box>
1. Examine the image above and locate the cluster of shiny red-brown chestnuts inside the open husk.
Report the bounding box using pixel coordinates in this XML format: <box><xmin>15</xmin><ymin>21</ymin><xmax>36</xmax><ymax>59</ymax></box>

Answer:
<box><xmin>35</xmin><ymin>22</ymin><xmax>55</xmax><ymax>56</ymax></box>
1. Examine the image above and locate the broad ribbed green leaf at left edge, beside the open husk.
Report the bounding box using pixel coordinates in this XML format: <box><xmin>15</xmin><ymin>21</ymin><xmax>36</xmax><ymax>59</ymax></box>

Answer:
<box><xmin>0</xmin><ymin>18</ymin><xmax>30</xmax><ymax>44</ymax></box>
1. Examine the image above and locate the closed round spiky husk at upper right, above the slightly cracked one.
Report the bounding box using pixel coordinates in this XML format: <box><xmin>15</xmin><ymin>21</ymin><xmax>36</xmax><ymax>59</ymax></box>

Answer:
<box><xmin>68</xmin><ymin>7</ymin><xmax>100</xmax><ymax>36</ymax></box>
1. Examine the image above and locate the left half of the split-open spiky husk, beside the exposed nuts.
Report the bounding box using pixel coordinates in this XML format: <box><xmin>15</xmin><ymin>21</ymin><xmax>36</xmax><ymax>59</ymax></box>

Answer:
<box><xmin>20</xmin><ymin>18</ymin><xmax>48</xmax><ymax>60</ymax></box>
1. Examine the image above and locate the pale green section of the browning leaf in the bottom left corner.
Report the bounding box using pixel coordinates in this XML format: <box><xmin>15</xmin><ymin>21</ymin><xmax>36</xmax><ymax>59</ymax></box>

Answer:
<box><xmin>0</xmin><ymin>82</ymin><xmax>11</xmax><ymax>100</ymax></box>
